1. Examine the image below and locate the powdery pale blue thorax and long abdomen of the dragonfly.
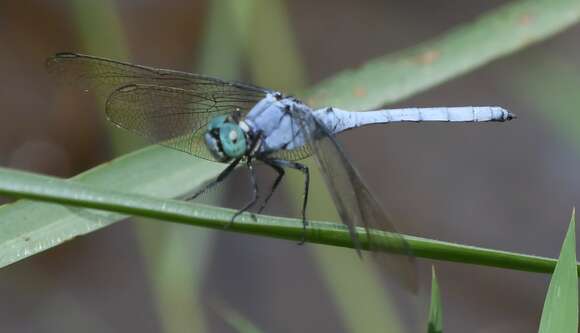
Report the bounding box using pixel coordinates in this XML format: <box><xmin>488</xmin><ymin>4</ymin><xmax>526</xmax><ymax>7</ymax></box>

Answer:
<box><xmin>244</xmin><ymin>94</ymin><xmax>513</xmax><ymax>153</ymax></box>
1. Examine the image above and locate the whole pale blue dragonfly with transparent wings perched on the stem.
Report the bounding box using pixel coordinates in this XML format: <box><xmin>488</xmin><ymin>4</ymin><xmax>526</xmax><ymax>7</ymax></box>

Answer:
<box><xmin>47</xmin><ymin>53</ymin><xmax>513</xmax><ymax>290</ymax></box>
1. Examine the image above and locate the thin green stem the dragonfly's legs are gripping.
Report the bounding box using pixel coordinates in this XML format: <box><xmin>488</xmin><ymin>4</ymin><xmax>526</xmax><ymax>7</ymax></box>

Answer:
<box><xmin>0</xmin><ymin>168</ymin><xmax>576</xmax><ymax>273</ymax></box>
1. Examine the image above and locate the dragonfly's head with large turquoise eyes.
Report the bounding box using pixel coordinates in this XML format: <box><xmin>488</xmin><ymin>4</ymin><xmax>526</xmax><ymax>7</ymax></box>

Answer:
<box><xmin>204</xmin><ymin>116</ymin><xmax>247</xmax><ymax>162</ymax></box>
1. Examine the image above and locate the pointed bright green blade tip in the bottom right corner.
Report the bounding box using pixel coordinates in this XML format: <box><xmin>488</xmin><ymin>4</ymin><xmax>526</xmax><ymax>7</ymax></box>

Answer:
<box><xmin>539</xmin><ymin>212</ymin><xmax>578</xmax><ymax>333</ymax></box>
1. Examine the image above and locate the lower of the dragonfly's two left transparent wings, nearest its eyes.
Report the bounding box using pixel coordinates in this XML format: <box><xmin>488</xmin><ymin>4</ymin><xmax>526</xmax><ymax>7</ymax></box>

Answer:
<box><xmin>105</xmin><ymin>84</ymin><xmax>256</xmax><ymax>161</ymax></box>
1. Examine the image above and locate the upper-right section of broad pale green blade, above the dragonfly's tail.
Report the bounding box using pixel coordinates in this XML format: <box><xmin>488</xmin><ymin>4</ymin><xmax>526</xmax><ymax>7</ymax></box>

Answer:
<box><xmin>306</xmin><ymin>0</ymin><xmax>580</xmax><ymax>110</ymax></box>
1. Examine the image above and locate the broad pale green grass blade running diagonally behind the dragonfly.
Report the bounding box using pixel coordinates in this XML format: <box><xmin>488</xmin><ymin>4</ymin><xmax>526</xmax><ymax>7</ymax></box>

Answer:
<box><xmin>0</xmin><ymin>0</ymin><xmax>580</xmax><ymax>269</ymax></box>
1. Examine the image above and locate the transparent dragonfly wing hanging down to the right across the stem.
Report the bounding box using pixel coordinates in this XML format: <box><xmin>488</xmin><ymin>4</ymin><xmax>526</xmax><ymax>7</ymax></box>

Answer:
<box><xmin>295</xmin><ymin>107</ymin><xmax>417</xmax><ymax>290</ymax></box>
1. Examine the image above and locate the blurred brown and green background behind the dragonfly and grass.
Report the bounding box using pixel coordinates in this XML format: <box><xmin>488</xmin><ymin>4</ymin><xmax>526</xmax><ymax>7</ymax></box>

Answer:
<box><xmin>0</xmin><ymin>0</ymin><xmax>580</xmax><ymax>332</ymax></box>
